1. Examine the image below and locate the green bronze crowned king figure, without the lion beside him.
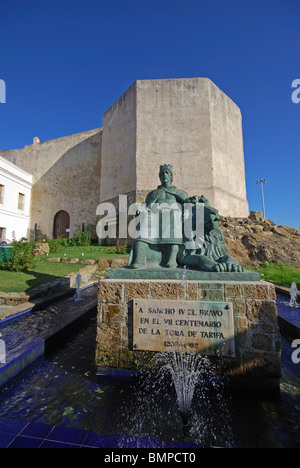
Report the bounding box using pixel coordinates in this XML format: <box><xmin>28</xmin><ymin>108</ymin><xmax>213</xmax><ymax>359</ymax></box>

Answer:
<box><xmin>128</xmin><ymin>164</ymin><xmax>188</xmax><ymax>269</ymax></box>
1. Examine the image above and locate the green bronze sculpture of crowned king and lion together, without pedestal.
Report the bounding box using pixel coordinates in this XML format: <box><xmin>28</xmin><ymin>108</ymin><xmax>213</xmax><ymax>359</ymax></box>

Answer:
<box><xmin>129</xmin><ymin>164</ymin><xmax>244</xmax><ymax>272</ymax></box>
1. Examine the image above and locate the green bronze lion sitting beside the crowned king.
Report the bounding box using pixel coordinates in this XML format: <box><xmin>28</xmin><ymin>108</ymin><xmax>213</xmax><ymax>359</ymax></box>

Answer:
<box><xmin>180</xmin><ymin>195</ymin><xmax>244</xmax><ymax>272</ymax></box>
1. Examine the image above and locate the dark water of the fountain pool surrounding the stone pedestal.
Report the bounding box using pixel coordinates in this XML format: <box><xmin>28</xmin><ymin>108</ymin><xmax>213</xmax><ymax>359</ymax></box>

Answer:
<box><xmin>0</xmin><ymin>286</ymin><xmax>300</xmax><ymax>450</ymax></box>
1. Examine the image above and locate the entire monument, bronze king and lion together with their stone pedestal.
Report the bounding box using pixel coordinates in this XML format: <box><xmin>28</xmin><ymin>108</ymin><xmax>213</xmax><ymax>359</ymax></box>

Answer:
<box><xmin>96</xmin><ymin>164</ymin><xmax>281</xmax><ymax>394</ymax></box>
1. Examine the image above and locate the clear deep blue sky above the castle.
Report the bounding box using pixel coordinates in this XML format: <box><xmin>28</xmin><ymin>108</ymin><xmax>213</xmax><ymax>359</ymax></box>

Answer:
<box><xmin>0</xmin><ymin>0</ymin><xmax>300</xmax><ymax>229</ymax></box>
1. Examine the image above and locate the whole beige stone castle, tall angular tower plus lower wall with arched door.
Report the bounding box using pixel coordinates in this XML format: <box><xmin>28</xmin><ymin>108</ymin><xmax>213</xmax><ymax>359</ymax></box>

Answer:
<box><xmin>0</xmin><ymin>78</ymin><xmax>249</xmax><ymax>238</ymax></box>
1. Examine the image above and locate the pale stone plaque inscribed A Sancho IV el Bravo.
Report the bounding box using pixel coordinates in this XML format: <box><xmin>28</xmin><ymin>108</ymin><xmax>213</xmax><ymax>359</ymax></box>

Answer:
<box><xmin>133</xmin><ymin>299</ymin><xmax>235</xmax><ymax>357</ymax></box>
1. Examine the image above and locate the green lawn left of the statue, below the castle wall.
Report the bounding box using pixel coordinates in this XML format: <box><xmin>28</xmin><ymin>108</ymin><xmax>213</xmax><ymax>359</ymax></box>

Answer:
<box><xmin>0</xmin><ymin>246</ymin><xmax>125</xmax><ymax>292</ymax></box>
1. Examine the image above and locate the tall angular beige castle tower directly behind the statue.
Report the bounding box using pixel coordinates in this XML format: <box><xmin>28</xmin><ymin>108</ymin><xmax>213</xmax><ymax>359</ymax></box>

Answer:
<box><xmin>100</xmin><ymin>78</ymin><xmax>249</xmax><ymax>217</ymax></box>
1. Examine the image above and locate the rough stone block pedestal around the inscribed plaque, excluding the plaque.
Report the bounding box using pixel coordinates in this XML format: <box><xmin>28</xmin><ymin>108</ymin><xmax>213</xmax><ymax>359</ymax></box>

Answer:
<box><xmin>96</xmin><ymin>279</ymin><xmax>281</xmax><ymax>386</ymax></box>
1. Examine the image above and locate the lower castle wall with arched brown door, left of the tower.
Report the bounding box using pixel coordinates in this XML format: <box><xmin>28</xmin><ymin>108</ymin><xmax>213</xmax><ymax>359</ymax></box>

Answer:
<box><xmin>0</xmin><ymin>129</ymin><xmax>102</xmax><ymax>238</ymax></box>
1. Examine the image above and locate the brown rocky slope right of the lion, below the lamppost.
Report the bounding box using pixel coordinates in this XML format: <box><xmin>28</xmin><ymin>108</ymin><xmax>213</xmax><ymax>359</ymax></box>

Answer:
<box><xmin>220</xmin><ymin>211</ymin><xmax>300</xmax><ymax>268</ymax></box>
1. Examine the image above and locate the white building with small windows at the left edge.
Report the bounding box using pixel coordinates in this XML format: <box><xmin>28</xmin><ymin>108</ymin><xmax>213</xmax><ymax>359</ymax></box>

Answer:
<box><xmin>0</xmin><ymin>156</ymin><xmax>32</xmax><ymax>241</ymax></box>
